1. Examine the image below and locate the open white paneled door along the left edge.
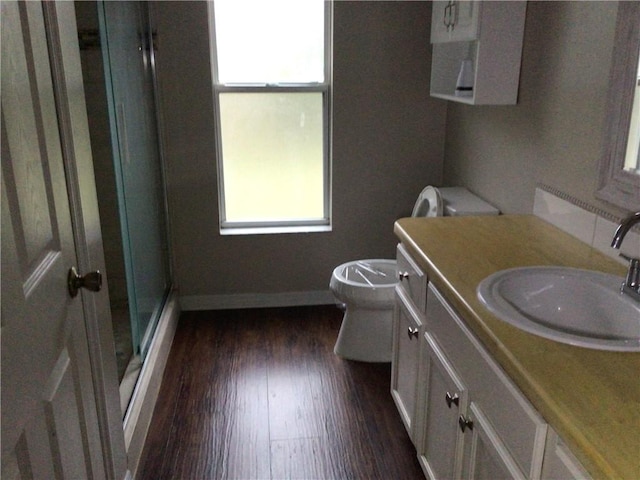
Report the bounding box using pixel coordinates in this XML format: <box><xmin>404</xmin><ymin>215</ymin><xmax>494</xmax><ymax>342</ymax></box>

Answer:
<box><xmin>0</xmin><ymin>1</ymin><xmax>126</xmax><ymax>479</ymax></box>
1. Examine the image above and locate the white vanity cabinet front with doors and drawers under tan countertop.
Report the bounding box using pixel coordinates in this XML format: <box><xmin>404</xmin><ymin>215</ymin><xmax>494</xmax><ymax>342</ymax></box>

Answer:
<box><xmin>391</xmin><ymin>245</ymin><xmax>588</xmax><ymax>479</ymax></box>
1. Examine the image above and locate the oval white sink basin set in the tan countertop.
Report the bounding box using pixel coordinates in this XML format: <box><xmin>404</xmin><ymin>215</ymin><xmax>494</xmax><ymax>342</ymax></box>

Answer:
<box><xmin>477</xmin><ymin>267</ymin><xmax>640</xmax><ymax>352</ymax></box>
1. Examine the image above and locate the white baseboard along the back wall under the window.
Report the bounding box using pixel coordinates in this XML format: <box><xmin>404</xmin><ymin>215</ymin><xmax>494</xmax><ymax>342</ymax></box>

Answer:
<box><xmin>180</xmin><ymin>290</ymin><xmax>336</xmax><ymax>310</ymax></box>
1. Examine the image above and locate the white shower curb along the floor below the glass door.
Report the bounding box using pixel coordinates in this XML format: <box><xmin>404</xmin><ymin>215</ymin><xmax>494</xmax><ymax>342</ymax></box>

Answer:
<box><xmin>124</xmin><ymin>292</ymin><xmax>181</xmax><ymax>478</ymax></box>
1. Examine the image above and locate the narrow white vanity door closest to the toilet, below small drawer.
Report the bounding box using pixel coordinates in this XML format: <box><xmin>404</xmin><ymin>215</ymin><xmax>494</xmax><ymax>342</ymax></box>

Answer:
<box><xmin>391</xmin><ymin>287</ymin><xmax>422</xmax><ymax>442</ymax></box>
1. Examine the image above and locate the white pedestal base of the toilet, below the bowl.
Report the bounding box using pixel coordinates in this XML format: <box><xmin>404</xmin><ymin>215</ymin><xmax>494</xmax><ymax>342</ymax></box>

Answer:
<box><xmin>333</xmin><ymin>305</ymin><xmax>393</xmax><ymax>362</ymax></box>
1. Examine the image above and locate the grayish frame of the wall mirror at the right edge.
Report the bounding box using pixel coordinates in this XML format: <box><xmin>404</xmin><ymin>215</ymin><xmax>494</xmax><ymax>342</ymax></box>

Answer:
<box><xmin>596</xmin><ymin>1</ymin><xmax>640</xmax><ymax>211</ymax></box>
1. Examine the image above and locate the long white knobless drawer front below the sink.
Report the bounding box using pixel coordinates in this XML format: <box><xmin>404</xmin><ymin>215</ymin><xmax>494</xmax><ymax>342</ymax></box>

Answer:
<box><xmin>426</xmin><ymin>284</ymin><xmax>547</xmax><ymax>478</ymax></box>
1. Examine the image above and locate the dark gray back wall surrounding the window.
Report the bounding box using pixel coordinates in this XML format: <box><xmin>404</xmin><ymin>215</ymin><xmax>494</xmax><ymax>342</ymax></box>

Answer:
<box><xmin>157</xmin><ymin>1</ymin><xmax>446</xmax><ymax>297</ymax></box>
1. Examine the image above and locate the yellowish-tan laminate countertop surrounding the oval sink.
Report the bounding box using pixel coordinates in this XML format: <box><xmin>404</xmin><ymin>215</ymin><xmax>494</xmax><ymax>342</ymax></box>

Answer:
<box><xmin>394</xmin><ymin>215</ymin><xmax>640</xmax><ymax>480</ymax></box>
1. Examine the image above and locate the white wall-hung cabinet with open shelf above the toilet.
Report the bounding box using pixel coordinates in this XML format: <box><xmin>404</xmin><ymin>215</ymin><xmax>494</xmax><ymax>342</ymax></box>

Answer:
<box><xmin>430</xmin><ymin>0</ymin><xmax>526</xmax><ymax>105</ymax></box>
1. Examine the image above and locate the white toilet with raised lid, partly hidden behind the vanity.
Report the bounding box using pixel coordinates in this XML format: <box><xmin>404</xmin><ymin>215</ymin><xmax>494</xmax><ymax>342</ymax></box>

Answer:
<box><xmin>329</xmin><ymin>186</ymin><xmax>500</xmax><ymax>362</ymax></box>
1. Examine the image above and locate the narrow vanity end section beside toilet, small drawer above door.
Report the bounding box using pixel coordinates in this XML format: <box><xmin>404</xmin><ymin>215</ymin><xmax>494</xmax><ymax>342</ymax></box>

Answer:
<box><xmin>391</xmin><ymin>245</ymin><xmax>427</xmax><ymax>440</ymax></box>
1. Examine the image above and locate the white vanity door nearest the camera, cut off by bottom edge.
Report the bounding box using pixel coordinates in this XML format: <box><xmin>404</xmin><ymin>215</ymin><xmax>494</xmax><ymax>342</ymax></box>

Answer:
<box><xmin>459</xmin><ymin>401</ymin><xmax>526</xmax><ymax>480</ymax></box>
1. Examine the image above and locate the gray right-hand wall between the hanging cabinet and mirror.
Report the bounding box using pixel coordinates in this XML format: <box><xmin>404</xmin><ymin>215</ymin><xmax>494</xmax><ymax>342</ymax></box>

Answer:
<box><xmin>444</xmin><ymin>1</ymin><xmax>621</xmax><ymax>216</ymax></box>
